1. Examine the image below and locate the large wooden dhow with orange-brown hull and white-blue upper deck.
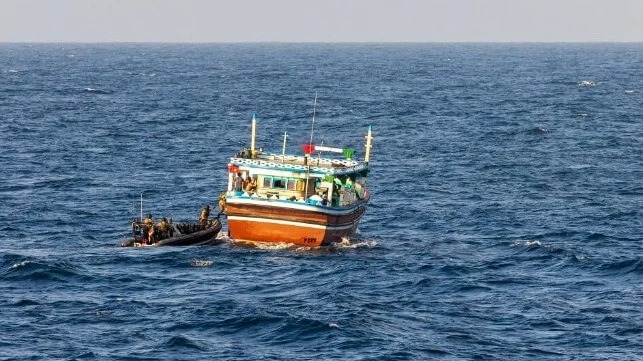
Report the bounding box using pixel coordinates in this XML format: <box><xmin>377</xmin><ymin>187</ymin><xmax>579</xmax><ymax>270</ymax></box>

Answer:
<box><xmin>219</xmin><ymin>112</ymin><xmax>373</xmax><ymax>247</ymax></box>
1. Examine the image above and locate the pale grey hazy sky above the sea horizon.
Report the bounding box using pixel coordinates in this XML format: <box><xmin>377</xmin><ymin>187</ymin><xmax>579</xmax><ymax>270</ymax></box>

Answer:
<box><xmin>0</xmin><ymin>0</ymin><xmax>643</xmax><ymax>42</ymax></box>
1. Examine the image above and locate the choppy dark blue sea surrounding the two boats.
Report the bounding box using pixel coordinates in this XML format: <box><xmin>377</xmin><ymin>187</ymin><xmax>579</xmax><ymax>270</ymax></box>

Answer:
<box><xmin>0</xmin><ymin>43</ymin><xmax>643</xmax><ymax>360</ymax></box>
